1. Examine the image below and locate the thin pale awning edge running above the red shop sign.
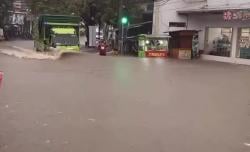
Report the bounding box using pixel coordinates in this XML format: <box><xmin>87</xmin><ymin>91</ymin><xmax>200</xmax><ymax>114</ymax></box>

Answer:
<box><xmin>177</xmin><ymin>4</ymin><xmax>250</xmax><ymax>14</ymax></box>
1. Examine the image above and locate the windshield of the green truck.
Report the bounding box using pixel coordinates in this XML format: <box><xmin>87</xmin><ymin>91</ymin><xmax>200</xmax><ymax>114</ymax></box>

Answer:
<box><xmin>52</xmin><ymin>34</ymin><xmax>79</xmax><ymax>46</ymax></box>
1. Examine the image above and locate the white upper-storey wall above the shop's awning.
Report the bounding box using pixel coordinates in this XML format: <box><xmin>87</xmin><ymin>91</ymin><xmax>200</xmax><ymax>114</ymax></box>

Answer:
<box><xmin>153</xmin><ymin>0</ymin><xmax>250</xmax><ymax>34</ymax></box>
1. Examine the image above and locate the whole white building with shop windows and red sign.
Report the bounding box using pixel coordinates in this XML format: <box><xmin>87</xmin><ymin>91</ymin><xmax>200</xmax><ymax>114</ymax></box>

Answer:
<box><xmin>153</xmin><ymin>0</ymin><xmax>250</xmax><ymax>65</ymax></box>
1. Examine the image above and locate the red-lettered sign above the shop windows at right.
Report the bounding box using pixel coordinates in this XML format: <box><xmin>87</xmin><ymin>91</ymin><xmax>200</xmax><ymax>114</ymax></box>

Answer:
<box><xmin>223</xmin><ymin>10</ymin><xmax>250</xmax><ymax>21</ymax></box>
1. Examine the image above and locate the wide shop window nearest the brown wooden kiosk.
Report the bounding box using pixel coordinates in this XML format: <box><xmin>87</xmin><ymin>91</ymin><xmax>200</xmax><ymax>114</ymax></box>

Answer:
<box><xmin>205</xmin><ymin>28</ymin><xmax>233</xmax><ymax>57</ymax></box>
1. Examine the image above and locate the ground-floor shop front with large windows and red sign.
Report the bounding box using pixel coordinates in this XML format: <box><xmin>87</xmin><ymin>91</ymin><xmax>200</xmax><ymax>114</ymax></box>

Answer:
<box><xmin>178</xmin><ymin>8</ymin><xmax>250</xmax><ymax>65</ymax></box>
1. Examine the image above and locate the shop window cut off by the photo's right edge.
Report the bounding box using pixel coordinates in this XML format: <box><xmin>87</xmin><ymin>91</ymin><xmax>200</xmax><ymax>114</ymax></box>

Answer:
<box><xmin>238</xmin><ymin>28</ymin><xmax>250</xmax><ymax>59</ymax></box>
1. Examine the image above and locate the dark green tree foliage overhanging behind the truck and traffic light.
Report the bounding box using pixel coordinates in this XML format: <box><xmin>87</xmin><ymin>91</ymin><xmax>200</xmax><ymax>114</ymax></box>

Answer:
<box><xmin>27</xmin><ymin>0</ymin><xmax>152</xmax><ymax>26</ymax></box>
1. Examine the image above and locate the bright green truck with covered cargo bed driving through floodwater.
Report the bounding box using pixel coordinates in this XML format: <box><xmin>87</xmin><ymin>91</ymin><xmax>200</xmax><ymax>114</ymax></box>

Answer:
<box><xmin>33</xmin><ymin>15</ymin><xmax>80</xmax><ymax>53</ymax></box>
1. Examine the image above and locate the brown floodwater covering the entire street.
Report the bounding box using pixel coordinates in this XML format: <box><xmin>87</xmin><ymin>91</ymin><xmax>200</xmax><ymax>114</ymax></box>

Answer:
<box><xmin>0</xmin><ymin>39</ymin><xmax>250</xmax><ymax>152</ymax></box>
